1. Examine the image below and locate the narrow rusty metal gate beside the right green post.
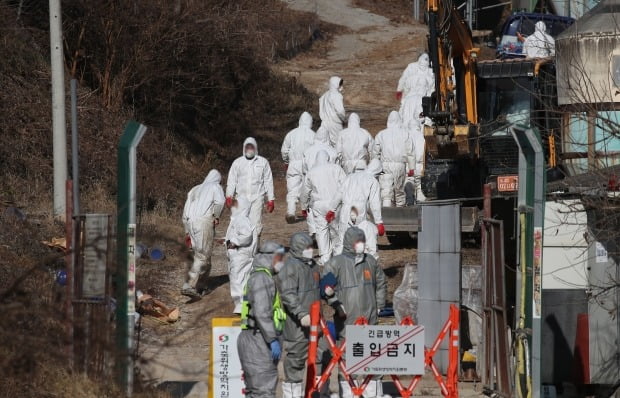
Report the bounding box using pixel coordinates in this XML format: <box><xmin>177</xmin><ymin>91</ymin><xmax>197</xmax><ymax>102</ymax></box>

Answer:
<box><xmin>480</xmin><ymin>219</ymin><xmax>512</xmax><ymax>397</ymax></box>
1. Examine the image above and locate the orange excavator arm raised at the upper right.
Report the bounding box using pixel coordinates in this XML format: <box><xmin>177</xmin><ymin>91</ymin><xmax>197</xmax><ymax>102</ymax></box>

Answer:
<box><xmin>423</xmin><ymin>0</ymin><xmax>479</xmax><ymax>157</ymax></box>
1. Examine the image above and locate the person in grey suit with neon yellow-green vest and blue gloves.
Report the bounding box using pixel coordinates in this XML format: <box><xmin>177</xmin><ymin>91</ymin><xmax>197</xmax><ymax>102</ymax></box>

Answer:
<box><xmin>237</xmin><ymin>241</ymin><xmax>284</xmax><ymax>398</ymax></box>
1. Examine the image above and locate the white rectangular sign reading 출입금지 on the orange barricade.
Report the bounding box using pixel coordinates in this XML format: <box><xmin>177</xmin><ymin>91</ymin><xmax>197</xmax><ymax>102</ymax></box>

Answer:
<box><xmin>345</xmin><ymin>325</ymin><xmax>424</xmax><ymax>375</ymax></box>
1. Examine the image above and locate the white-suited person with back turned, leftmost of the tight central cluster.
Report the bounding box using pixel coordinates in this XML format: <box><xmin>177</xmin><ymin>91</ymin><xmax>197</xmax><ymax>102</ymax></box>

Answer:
<box><xmin>282</xmin><ymin>112</ymin><xmax>314</xmax><ymax>224</ymax></box>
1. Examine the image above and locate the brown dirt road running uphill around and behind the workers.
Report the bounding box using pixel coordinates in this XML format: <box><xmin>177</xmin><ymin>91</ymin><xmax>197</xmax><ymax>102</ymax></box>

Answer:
<box><xmin>138</xmin><ymin>0</ymin><xmax>480</xmax><ymax>397</ymax></box>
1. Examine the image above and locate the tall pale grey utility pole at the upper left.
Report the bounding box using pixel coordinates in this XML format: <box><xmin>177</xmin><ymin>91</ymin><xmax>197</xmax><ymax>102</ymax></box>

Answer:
<box><xmin>49</xmin><ymin>0</ymin><xmax>67</xmax><ymax>221</ymax></box>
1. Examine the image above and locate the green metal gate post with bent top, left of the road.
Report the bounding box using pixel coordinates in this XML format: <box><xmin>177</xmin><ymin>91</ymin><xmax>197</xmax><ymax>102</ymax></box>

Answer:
<box><xmin>115</xmin><ymin>121</ymin><xmax>146</xmax><ymax>397</ymax></box>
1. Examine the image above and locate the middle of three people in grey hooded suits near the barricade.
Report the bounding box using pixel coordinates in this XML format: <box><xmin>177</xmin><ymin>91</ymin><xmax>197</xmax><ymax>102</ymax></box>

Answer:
<box><xmin>277</xmin><ymin>232</ymin><xmax>321</xmax><ymax>398</ymax></box>
